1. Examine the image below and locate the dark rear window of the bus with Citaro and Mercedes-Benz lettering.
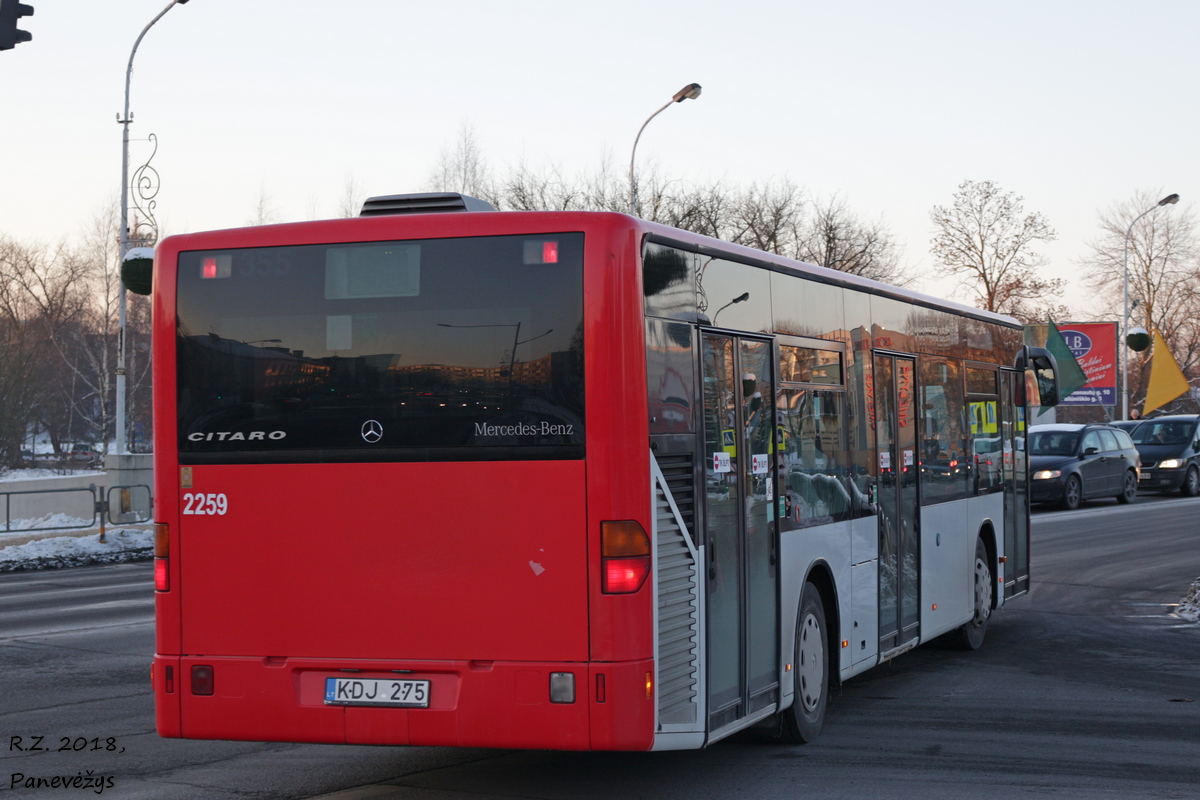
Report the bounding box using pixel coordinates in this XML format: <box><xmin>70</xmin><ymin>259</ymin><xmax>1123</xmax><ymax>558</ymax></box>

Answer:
<box><xmin>176</xmin><ymin>233</ymin><xmax>583</xmax><ymax>464</ymax></box>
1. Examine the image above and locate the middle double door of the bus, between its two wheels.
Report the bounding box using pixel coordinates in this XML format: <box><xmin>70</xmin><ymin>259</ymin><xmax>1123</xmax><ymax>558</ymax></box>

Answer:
<box><xmin>875</xmin><ymin>353</ymin><xmax>920</xmax><ymax>655</ymax></box>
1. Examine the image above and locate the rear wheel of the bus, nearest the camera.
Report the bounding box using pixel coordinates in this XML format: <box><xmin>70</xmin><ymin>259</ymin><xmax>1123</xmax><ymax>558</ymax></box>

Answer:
<box><xmin>782</xmin><ymin>583</ymin><xmax>829</xmax><ymax>745</ymax></box>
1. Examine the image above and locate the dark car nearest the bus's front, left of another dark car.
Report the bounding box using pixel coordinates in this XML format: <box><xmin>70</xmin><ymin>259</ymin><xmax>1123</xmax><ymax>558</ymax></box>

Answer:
<box><xmin>1028</xmin><ymin>425</ymin><xmax>1139</xmax><ymax>509</ymax></box>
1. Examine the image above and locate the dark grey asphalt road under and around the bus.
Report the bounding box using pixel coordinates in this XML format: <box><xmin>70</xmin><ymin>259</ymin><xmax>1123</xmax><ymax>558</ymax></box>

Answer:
<box><xmin>0</xmin><ymin>495</ymin><xmax>1200</xmax><ymax>800</ymax></box>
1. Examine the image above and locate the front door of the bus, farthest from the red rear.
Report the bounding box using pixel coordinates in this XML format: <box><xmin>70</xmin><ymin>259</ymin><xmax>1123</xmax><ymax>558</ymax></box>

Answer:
<box><xmin>1000</xmin><ymin>369</ymin><xmax>1030</xmax><ymax>597</ymax></box>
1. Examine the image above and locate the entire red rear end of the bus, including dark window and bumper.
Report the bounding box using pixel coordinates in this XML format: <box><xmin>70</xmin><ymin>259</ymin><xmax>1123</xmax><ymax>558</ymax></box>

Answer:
<box><xmin>154</xmin><ymin>206</ymin><xmax>654</xmax><ymax>750</ymax></box>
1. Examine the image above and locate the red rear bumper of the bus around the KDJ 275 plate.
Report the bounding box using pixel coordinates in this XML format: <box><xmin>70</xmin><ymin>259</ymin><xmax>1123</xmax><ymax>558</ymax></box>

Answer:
<box><xmin>154</xmin><ymin>656</ymin><xmax>654</xmax><ymax>750</ymax></box>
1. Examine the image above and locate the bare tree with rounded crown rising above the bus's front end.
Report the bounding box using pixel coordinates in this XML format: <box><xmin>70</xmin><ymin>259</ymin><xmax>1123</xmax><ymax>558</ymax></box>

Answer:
<box><xmin>929</xmin><ymin>181</ymin><xmax>1067</xmax><ymax>321</ymax></box>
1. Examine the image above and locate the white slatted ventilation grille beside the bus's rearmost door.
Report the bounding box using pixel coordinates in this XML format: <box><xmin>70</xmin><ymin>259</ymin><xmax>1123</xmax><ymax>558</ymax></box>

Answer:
<box><xmin>654</xmin><ymin>472</ymin><xmax>700</xmax><ymax>724</ymax></box>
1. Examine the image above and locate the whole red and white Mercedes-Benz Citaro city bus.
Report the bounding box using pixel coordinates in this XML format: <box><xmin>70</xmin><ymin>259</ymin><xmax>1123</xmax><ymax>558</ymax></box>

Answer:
<box><xmin>152</xmin><ymin>196</ymin><xmax>1055</xmax><ymax>750</ymax></box>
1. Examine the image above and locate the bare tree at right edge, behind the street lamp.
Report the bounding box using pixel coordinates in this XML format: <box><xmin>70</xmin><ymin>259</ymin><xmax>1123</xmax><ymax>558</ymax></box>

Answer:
<box><xmin>1080</xmin><ymin>191</ymin><xmax>1200</xmax><ymax>403</ymax></box>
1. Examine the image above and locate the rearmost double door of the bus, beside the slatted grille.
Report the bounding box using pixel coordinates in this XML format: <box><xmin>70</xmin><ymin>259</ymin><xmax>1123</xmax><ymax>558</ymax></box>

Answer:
<box><xmin>702</xmin><ymin>332</ymin><xmax>779</xmax><ymax>732</ymax></box>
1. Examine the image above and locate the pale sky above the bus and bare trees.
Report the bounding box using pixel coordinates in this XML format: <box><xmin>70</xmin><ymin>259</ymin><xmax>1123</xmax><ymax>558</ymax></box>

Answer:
<box><xmin>0</xmin><ymin>0</ymin><xmax>1200</xmax><ymax>318</ymax></box>
